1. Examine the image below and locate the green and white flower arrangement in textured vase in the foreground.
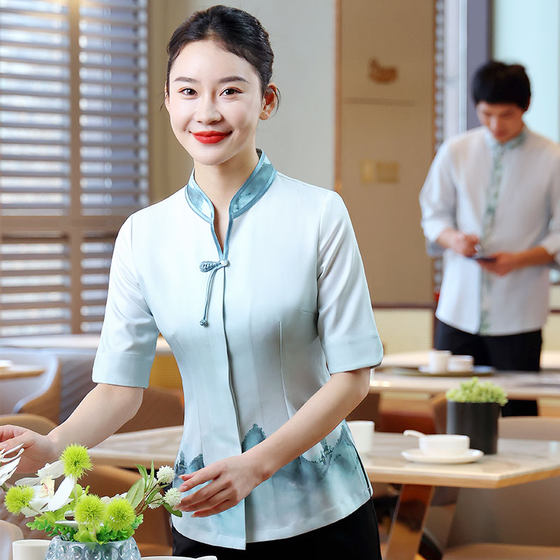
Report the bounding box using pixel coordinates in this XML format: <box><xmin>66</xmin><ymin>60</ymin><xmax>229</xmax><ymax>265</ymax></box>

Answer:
<box><xmin>0</xmin><ymin>445</ymin><xmax>182</xmax><ymax>560</ymax></box>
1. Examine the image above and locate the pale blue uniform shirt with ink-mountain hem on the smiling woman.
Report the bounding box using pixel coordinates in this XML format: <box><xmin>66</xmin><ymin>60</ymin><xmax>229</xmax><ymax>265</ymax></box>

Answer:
<box><xmin>93</xmin><ymin>154</ymin><xmax>382</xmax><ymax>548</ymax></box>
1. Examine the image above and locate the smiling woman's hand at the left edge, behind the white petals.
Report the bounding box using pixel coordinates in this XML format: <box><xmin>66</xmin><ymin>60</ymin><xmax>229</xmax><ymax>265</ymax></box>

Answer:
<box><xmin>0</xmin><ymin>425</ymin><xmax>58</xmax><ymax>473</ymax></box>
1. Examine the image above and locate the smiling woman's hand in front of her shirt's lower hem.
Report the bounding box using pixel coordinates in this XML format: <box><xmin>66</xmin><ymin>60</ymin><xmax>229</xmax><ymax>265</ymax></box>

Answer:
<box><xmin>177</xmin><ymin>453</ymin><xmax>265</xmax><ymax>517</ymax></box>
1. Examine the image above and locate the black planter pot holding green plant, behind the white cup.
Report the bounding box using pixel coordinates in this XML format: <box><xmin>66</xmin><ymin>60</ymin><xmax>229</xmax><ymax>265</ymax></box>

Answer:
<box><xmin>447</xmin><ymin>401</ymin><xmax>502</xmax><ymax>455</ymax></box>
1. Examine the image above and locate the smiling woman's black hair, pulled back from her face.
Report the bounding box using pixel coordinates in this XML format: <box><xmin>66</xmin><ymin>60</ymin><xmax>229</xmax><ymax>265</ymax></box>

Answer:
<box><xmin>165</xmin><ymin>6</ymin><xmax>274</xmax><ymax>95</ymax></box>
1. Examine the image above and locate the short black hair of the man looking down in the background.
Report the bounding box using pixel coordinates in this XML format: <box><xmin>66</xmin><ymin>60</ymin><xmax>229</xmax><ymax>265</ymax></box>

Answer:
<box><xmin>472</xmin><ymin>60</ymin><xmax>531</xmax><ymax>111</ymax></box>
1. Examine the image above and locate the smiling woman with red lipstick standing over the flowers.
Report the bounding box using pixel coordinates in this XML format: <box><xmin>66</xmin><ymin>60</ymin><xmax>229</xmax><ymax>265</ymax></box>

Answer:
<box><xmin>2</xmin><ymin>6</ymin><xmax>382</xmax><ymax>560</ymax></box>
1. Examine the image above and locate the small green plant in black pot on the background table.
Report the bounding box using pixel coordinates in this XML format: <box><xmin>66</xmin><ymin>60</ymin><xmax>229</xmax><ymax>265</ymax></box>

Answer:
<box><xmin>446</xmin><ymin>377</ymin><xmax>507</xmax><ymax>454</ymax></box>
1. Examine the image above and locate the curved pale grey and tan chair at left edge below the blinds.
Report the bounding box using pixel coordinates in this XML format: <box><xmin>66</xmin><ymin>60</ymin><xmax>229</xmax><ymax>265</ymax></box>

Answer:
<box><xmin>0</xmin><ymin>348</ymin><xmax>61</xmax><ymax>423</ymax></box>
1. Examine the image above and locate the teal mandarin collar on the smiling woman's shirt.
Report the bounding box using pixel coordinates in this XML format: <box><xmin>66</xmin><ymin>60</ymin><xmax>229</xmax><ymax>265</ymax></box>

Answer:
<box><xmin>185</xmin><ymin>150</ymin><xmax>277</xmax><ymax>224</ymax></box>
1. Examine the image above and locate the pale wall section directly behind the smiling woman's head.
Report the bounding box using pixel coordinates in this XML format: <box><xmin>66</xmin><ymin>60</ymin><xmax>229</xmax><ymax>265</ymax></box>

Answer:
<box><xmin>150</xmin><ymin>0</ymin><xmax>336</xmax><ymax>200</ymax></box>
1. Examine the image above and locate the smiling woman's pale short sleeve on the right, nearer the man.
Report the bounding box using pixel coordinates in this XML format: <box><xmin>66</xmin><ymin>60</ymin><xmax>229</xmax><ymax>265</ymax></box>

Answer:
<box><xmin>317</xmin><ymin>193</ymin><xmax>383</xmax><ymax>373</ymax></box>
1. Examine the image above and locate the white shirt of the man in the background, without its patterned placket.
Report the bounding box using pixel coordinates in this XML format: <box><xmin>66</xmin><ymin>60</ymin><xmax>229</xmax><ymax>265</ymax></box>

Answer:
<box><xmin>420</xmin><ymin>127</ymin><xmax>560</xmax><ymax>335</ymax></box>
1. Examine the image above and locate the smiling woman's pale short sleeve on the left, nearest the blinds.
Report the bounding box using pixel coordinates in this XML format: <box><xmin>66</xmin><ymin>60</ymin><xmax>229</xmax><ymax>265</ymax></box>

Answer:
<box><xmin>93</xmin><ymin>218</ymin><xmax>159</xmax><ymax>387</ymax></box>
